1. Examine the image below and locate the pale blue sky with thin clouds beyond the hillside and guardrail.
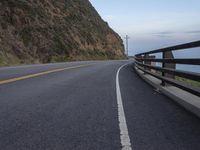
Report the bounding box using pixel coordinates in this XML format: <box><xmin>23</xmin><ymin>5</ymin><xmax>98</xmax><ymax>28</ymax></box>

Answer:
<box><xmin>90</xmin><ymin>0</ymin><xmax>200</xmax><ymax>58</ymax></box>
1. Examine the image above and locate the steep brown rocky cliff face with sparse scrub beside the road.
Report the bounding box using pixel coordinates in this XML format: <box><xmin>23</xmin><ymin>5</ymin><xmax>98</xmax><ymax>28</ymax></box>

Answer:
<box><xmin>0</xmin><ymin>0</ymin><xmax>124</xmax><ymax>65</ymax></box>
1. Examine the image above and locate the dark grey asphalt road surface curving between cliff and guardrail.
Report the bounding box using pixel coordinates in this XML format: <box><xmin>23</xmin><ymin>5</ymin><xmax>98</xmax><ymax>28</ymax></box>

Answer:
<box><xmin>0</xmin><ymin>61</ymin><xmax>200</xmax><ymax>150</ymax></box>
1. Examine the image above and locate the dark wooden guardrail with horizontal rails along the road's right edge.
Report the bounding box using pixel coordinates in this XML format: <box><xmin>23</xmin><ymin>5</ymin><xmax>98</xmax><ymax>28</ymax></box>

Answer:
<box><xmin>135</xmin><ymin>41</ymin><xmax>200</xmax><ymax>96</ymax></box>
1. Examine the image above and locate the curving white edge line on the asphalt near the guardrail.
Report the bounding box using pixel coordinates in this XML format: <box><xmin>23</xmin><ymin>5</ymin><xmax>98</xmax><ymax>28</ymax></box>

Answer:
<box><xmin>116</xmin><ymin>64</ymin><xmax>132</xmax><ymax>150</ymax></box>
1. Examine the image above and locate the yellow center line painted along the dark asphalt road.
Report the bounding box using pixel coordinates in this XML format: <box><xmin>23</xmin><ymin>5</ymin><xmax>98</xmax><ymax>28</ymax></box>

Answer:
<box><xmin>0</xmin><ymin>64</ymin><xmax>93</xmax><ymax>85</ymax></box>
